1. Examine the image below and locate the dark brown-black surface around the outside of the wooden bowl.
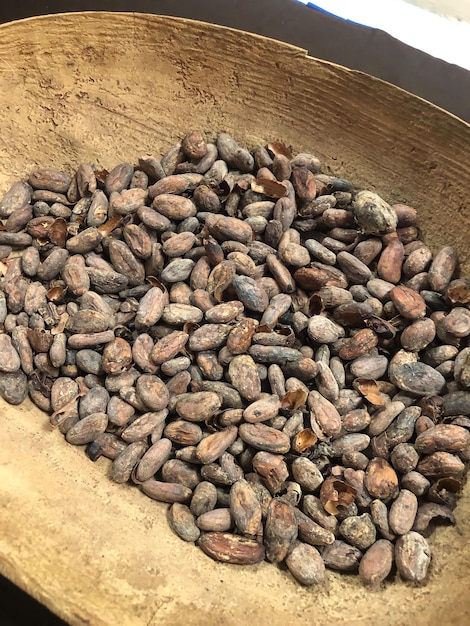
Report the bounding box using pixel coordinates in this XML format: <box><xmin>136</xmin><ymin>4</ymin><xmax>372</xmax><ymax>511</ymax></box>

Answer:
<box><xmin>0</xmin><ymin>0</ymin><xmax>470</xmax><ymax>626</ymax></box>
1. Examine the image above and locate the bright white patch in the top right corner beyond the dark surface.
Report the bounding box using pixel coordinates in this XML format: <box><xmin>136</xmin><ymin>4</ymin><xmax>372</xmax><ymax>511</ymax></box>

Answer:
<box><xmin>298</xmin><ymin>0</ymin><xmax>470</xmax><ymax>70</ymax></box>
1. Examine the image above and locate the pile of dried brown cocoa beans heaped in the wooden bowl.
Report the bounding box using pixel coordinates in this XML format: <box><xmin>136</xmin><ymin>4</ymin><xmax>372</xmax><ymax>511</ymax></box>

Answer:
<box><xmin>0</xmin><ymin>131</ymin><xmax>470</xmax><ymax>585</ymax></box>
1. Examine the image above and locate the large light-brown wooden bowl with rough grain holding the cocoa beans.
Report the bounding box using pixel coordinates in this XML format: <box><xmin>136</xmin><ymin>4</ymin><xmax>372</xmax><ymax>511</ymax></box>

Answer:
<box><xmin>0</xmin><ymin>13</ymin><xmax>470</xmax><ymax>626</ymax></box>
